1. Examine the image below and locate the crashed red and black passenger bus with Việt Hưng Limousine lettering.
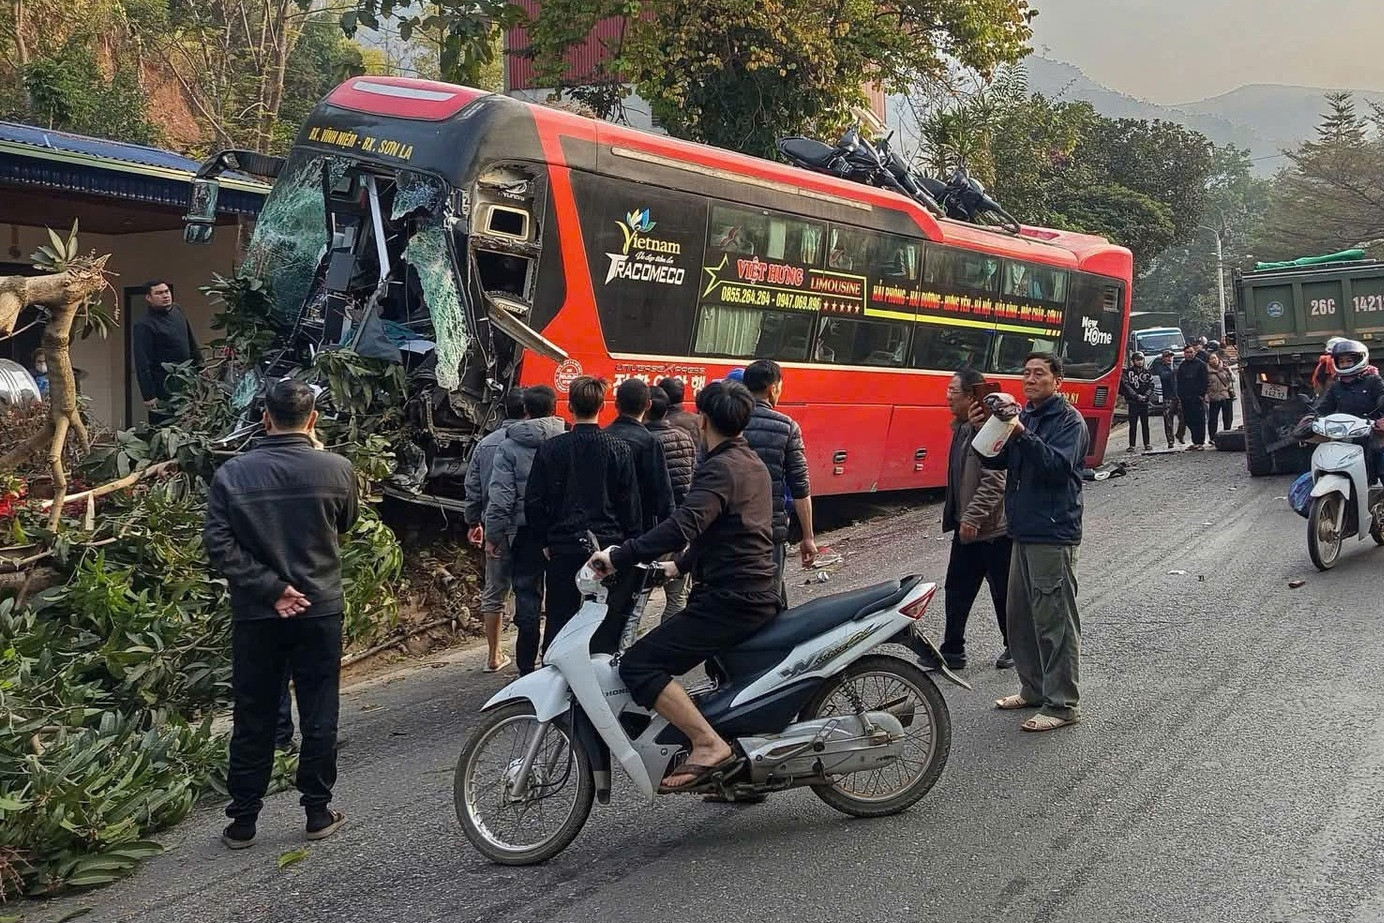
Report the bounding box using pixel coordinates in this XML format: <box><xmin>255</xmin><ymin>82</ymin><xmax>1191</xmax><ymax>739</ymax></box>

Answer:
<box><xmin>186</xmin><ymin>77</ymin><xmax>1132</xmax><ymax>494</ymax></box>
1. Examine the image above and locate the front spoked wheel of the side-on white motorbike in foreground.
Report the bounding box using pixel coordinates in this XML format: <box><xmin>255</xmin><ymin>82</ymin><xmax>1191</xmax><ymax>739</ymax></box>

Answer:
<box><xmin>453</xmin><ymin>702</ymin><xmax>597</xmax><ymax>865</ymax></box>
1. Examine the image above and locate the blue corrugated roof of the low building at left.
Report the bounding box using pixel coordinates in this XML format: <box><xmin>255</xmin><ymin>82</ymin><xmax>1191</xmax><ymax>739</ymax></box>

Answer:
<box><xmin>0</xmin><ymin>122</ymin><xmax>268</xmax><ymax>216</ymax></box>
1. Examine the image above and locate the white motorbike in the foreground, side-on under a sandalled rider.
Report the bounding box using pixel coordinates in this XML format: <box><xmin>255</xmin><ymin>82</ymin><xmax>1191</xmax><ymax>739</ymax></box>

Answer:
<box><xmin>454</xmin><ymin>541</ymin><xmax>970</xmax><ymax>865</ymax></box>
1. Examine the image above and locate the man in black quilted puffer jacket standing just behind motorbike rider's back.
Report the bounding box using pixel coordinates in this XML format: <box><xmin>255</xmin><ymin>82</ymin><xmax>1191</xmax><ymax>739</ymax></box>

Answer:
<box><xmin>743</xmin><ymin>358</ymin><xmax>817</xmax><ymax>606</ymax></box>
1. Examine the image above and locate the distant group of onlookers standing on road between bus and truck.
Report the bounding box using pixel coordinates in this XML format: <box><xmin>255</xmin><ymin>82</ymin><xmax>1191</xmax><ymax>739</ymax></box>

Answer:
<box><xmin>1120</xmin><ymin>336</ymin><xmax>1236</xmax><ymax>453</ymax></box>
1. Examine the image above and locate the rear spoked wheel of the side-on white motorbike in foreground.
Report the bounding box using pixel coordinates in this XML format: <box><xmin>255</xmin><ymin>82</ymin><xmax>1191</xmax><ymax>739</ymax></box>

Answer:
<box><xmin>801</xmin><ymin>655</ymin><xmax>951</xmax><ymax>818</ymax></box>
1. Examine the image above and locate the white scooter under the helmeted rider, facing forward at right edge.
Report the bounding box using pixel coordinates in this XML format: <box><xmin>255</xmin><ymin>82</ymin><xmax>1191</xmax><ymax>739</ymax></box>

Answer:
<box><xmin>1306</xmin><ymin>414</ymin><xmax>1384</xmax><ymax>570</ymax></box>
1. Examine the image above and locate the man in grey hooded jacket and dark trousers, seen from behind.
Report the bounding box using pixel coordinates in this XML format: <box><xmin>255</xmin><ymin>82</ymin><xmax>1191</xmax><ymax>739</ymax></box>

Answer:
<box><xmin>486</xmin><ymin>385</ymin><xmax>565</xmax><ymax>670</ymax></box>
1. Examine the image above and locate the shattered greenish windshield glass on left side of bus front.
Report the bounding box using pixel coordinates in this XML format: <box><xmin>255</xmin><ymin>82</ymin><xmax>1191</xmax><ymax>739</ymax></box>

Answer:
<box><xmin>245</xmin><ymin>151</ymin><xmax>334</xmax><ymax>321</ymax></box>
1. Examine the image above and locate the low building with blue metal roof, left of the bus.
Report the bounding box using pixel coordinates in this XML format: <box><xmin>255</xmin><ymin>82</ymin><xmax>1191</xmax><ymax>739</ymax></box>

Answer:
<box><xmin>0</xmin><ymin>122</ymin><xmax>268</xmax><ymax>428</ymax></box>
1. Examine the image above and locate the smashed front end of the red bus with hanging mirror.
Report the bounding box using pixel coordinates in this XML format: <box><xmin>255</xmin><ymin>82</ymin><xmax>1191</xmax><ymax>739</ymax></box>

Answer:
<box><xmin>185</xmin><ymin>77</ymin><xmax>566</xmax><ymax>505</ymax></box>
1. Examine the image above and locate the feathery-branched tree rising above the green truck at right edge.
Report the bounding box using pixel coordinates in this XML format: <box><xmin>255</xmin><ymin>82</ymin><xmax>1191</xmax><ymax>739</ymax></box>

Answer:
<box><xmin>1255</xmin><ymin>93</ymin><xmax>1384</xmax><ymax>260</ymax></box>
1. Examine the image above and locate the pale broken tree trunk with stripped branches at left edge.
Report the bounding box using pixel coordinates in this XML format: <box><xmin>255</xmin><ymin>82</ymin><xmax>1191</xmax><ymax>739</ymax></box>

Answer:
<box><xmin>0</xmin><ymin>256</ymin><xmax>109</xmax><ymax>529</ymax></box>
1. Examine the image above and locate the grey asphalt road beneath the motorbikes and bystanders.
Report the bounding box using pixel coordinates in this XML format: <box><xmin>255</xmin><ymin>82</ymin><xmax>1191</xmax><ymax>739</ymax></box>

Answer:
<box><xmin>26</xmin><ymin>437</ymin><xmax>1384</xmax><ymax>923</ymax></box>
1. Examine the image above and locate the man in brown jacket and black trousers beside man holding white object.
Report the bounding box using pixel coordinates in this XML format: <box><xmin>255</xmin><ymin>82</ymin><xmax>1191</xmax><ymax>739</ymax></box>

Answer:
<box><xmin>941</xmin><ymin>368</ymin><xmax>1014</xmax><ymax>670</ymax></box>
